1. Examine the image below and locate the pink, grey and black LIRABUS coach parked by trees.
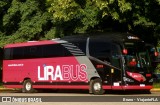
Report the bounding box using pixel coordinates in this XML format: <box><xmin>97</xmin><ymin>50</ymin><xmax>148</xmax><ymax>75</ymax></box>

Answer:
<box><xmin>3</xmin><ymin>33</ymin><xmax>153</xmax><ymax>94</ymax></box>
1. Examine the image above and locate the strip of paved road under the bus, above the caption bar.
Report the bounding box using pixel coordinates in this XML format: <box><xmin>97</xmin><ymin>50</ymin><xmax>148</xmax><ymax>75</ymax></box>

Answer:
<box><xmin>0</xmin><ymin>89</ymin><xmax>160</xmax><ymax>96</ymax></box>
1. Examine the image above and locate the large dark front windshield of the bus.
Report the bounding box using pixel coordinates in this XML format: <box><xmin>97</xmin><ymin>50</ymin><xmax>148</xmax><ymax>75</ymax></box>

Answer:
<box><xmin>124</xmin><ymin>42</ymin><xmax>151</xmax><ymax>72</ymax></box>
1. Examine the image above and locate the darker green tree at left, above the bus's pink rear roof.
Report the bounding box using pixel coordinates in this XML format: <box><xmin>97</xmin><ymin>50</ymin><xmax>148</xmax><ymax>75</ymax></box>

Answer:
<box><xmin>0</xmin><ymin>0</ymin><xmax>54</xmax><ymax>46</ymax></box>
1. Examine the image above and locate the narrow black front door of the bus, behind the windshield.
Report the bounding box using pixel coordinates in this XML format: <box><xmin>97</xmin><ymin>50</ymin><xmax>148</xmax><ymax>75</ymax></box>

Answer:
<box><xmin>111</xmin><ymin>44</ymin><xmax>122</xmax><ymax>90</ymax></box>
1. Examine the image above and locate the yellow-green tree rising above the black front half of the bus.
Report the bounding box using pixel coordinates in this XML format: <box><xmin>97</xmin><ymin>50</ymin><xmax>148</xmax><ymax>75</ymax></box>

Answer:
<box><xmin>47</xmin><ymin>0</ymin><xmax>160</xmax><ymax>43</ymax></box>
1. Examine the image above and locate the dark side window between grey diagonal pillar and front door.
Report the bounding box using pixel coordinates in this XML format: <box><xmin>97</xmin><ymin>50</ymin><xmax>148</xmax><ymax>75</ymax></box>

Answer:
<box><xmin>89</xmin><ymin>40</ymin><xmax>111</xmax><ymax>62</ymax></box>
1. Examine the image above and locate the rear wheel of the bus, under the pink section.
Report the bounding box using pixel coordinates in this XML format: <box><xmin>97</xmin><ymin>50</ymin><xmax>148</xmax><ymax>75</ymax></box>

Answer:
<box><xmin>22</xmin><ymin>79</ymin><xmax>34</xmax><ymax>93</ymax></box>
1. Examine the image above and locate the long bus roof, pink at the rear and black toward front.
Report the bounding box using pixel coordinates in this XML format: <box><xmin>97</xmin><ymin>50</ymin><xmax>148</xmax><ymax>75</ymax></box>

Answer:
<box><xmin>4</xmin><ymin>32</ymin><xmax>142</xmax><ymax>48</ymax></box>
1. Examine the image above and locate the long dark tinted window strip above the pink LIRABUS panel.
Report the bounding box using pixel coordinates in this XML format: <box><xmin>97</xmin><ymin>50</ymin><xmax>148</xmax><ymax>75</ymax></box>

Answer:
<box><xmin>4</xmin><ymin>44</ymin><xmax>72</xmax><ymax>59</ymax></box>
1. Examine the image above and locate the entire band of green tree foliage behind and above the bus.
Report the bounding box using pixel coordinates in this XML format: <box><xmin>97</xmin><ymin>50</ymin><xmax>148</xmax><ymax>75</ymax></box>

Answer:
<box><xmin>0</xmin><ymin>0</ymin><xmax>160</xmax><ymax>46</ymax></box>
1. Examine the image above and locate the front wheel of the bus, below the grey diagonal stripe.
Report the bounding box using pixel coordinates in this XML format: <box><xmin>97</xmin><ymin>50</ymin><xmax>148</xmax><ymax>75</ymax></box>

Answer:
<box><xmin>90</xmin><ymin>78</ymin><xmax>105</xmax><ymax>95</ymax></box>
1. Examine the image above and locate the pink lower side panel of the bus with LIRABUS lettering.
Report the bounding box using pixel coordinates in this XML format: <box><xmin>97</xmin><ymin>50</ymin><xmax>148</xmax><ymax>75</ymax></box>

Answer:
<box><xmin>3</xmin><ymin>57</ymin><xmax>88</xmax><ymax>87</ymax></box>
